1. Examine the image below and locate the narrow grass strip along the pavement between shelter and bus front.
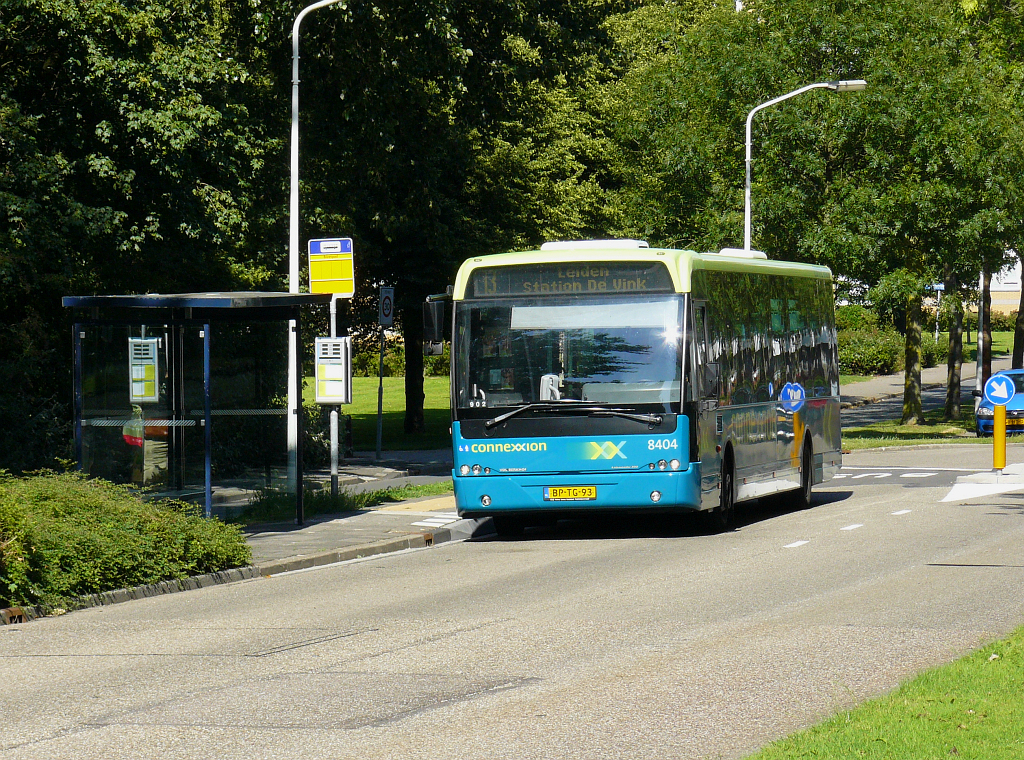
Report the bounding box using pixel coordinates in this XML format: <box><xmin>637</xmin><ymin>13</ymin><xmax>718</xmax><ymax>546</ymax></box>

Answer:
<box><xmin>235</xmin><ymin>480</ymin><xmax>453</xmax><ymax>525</ymax></box>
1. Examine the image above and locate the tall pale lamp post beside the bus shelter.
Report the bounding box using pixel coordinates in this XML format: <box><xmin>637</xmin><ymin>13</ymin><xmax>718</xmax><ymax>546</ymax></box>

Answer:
<box><xmin>288</xmin><ymin>0</ymin><xmax>341</xmax><ymax>514</ymax></box>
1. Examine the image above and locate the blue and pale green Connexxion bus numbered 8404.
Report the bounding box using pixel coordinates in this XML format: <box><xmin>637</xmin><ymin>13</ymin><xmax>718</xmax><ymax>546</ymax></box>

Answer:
<box><xmin>424</xmin><ymin>241</ymin><xmax>842</xmax><ymax>535</ymax></box>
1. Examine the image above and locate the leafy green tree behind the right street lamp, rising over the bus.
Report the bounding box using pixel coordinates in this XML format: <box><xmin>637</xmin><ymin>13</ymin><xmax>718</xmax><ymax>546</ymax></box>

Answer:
<box><xmin>606</xmin><ymin>0</ymin><xmax>1022</xmax><ymax>421</ymax></box>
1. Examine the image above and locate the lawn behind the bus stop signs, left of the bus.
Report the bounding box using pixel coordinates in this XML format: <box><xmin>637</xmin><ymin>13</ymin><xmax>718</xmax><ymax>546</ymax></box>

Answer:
<box><xmin>302</xmin><ymin>376</ymin><xmax>452</xmax><ymax>452</ymax></box>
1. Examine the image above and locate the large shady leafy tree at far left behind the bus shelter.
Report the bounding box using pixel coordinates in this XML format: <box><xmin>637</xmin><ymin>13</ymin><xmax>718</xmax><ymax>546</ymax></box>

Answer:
<box><xmin>0</xmin><ymin>0</ymin><xmax>276</xmax><ymax>469</ymax></box>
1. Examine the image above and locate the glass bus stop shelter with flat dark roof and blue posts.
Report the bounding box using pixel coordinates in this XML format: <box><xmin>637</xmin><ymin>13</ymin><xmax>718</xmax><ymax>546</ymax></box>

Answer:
<box><xmin>63</xmin><ymin>292</ymin><xmax>331</xmax><ymax>522</ymax></box>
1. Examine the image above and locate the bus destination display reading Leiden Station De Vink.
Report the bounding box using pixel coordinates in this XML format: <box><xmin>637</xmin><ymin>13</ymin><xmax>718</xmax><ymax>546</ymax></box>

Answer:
<box><xmin>469</xmin><ymin>261</ymin><xmax>674</xmax><ymax>298</ymax></box>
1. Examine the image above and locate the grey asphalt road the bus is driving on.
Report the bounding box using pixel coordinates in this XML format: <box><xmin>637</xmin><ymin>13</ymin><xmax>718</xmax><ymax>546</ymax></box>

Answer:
<box><xmin>0</xmin><ymin>446</ymin><xmax>1024</xmax><ymax>760</ymax></box>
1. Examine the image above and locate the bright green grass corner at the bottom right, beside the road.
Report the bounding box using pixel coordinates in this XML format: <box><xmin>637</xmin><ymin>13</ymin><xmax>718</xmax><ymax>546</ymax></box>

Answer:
<box><xmin>749</xmin><ymin>628</ymin><xmax>1024</xmax><ymax>760</ymax></box>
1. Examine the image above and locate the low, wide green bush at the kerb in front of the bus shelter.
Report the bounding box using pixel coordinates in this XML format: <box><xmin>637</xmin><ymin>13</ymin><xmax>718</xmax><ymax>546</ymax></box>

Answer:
<box><xmin>0</xmin><ymin>471</ymin><xmax>252</xmax><ymax>607</ymax></box>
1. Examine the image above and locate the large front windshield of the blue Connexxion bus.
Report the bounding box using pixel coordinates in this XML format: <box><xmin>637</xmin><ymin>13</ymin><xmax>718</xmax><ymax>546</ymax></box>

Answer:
<box><xmin>455</xmin><ymin>295</ymin><xmax>683</xmax><ymax>416</ymax></box>
